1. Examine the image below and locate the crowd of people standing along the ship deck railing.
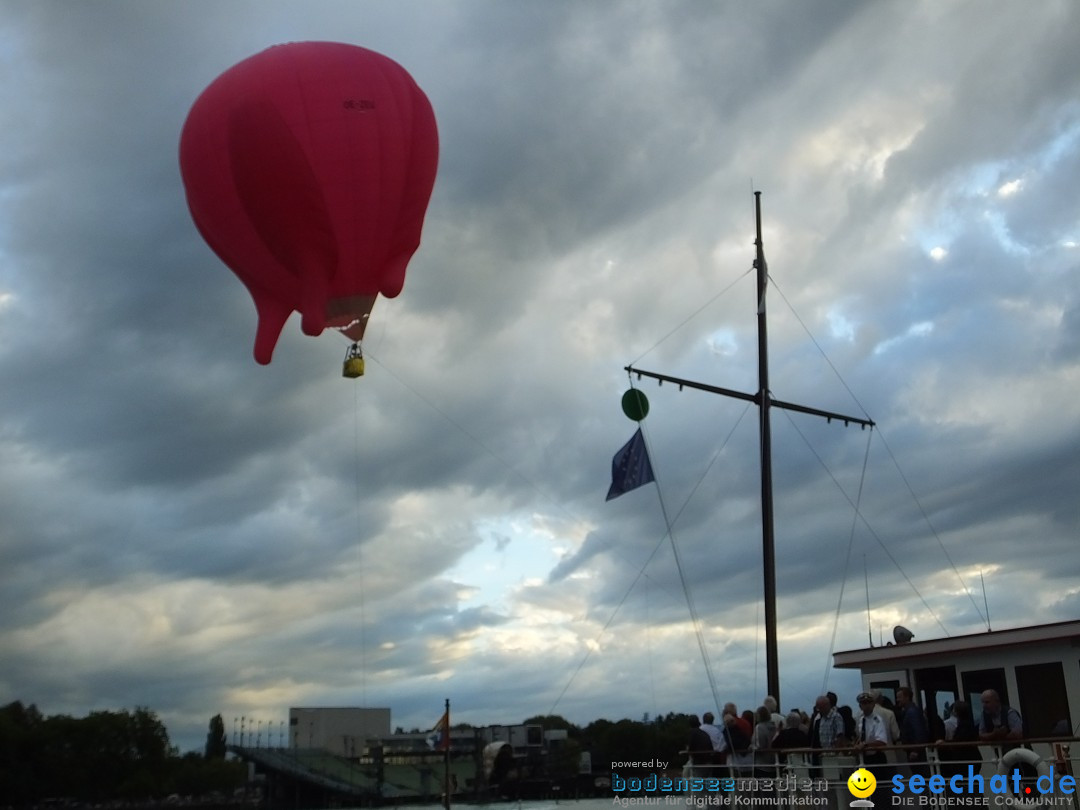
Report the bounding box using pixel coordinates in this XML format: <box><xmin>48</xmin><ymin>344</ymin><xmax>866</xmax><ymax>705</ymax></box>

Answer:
<box><xmin>687</xmin><ymin>687</ymin><xmax>1024</xmax><ymax>778</ymax></box>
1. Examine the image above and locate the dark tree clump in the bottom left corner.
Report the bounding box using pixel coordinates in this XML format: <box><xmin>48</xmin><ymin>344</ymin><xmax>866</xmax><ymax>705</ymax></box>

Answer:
<box><xmin>0</xmin><ymin>701</ymin><xmax>246</xmax><ymax>807</ymax></box>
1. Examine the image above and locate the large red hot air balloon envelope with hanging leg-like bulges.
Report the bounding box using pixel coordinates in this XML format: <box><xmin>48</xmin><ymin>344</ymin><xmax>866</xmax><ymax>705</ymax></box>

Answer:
<box><xmin>180</xmin><ymin>42</ymin><xmax>438</xmax><ymax>364</ymax></box>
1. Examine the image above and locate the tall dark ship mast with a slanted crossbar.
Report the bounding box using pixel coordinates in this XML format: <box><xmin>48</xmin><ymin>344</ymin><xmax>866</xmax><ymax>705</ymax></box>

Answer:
<box><xmin>625</xmin><ymin>191</ymin><xmax>874</xmax><ymax>705</ymax></box>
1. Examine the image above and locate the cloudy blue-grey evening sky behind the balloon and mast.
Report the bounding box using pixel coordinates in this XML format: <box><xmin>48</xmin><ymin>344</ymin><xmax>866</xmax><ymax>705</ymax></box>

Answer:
<box><xmin>0</xmin><ymin>0</ymin><xmax>1080</xmax><ymax>750</ymax></box>
